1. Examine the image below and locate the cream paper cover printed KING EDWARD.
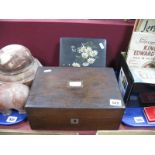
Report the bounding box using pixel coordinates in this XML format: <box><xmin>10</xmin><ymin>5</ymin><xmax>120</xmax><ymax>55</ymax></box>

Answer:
<box><xmin>127</xmin><ymin>32</ymin><xmax>155</xmax><ymax>68</ymax></box>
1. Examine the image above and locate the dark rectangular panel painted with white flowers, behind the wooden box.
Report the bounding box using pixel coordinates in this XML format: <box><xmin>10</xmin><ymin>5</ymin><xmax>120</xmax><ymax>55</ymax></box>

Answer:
<box><xmin>59</xmin><ymin>37</ymin><xmax>106</xmax><ymax>67</ymax></box>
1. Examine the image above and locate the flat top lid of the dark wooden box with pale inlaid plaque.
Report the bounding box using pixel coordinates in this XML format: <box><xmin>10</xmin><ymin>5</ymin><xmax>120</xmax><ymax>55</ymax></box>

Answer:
<box><xmin>26</xmin><ymin>67</ymin><xmax>125</xmax><ymax>109</ymax></box>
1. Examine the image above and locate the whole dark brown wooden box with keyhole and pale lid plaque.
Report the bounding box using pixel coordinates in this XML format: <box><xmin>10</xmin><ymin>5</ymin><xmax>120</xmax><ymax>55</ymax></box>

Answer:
<box><xmin>25</xmin><ymin>67</ymin><xmax>125</xmax><ymax>130</ymax></box>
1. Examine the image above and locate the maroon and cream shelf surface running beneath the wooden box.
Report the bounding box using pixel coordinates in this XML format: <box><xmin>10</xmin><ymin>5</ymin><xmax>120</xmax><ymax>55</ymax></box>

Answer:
<box><xmin>0</xmin><ymin>121</ymin><xmax>155</xmax><ymax>135</ymax></box>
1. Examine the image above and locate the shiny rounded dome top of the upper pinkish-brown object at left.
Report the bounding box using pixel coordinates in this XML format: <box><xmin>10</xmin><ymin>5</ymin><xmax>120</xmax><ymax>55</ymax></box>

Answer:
<box><xmin>0</xmin><ymin>44</ymin><xmax>34</xmax><ymax>74</ymax></box>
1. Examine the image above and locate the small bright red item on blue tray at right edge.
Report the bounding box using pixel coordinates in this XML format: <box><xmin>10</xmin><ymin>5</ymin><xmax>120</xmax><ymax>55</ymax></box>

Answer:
<box><xmin>144</xmin><ymin>106</ymin><xmax>155</xmax><ymax>122</ymax></box>
